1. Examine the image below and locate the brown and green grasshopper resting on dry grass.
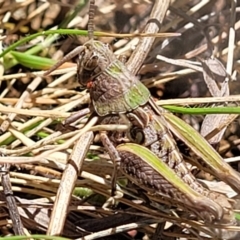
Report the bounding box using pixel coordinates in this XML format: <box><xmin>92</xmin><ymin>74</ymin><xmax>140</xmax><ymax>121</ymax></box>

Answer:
<box><xmin>45</xmin><ymin>0</ymin><xmax>240</xmax><ymax>225</ymax></box>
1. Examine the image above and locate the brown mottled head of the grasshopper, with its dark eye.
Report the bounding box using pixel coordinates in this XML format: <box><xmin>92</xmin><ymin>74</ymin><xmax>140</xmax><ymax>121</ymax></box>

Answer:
<box><xmin>77</xmin><ymin>40</ymin><xmax>115</xmax><ymax>87</ymax></box>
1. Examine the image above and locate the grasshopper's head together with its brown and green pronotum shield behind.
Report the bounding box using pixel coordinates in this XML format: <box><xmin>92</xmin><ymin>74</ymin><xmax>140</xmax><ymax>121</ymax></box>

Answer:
<box><xmin>77</xmin><ymin>40</ymin><xmax>150</xmax><ymax>116</ymax></box>
